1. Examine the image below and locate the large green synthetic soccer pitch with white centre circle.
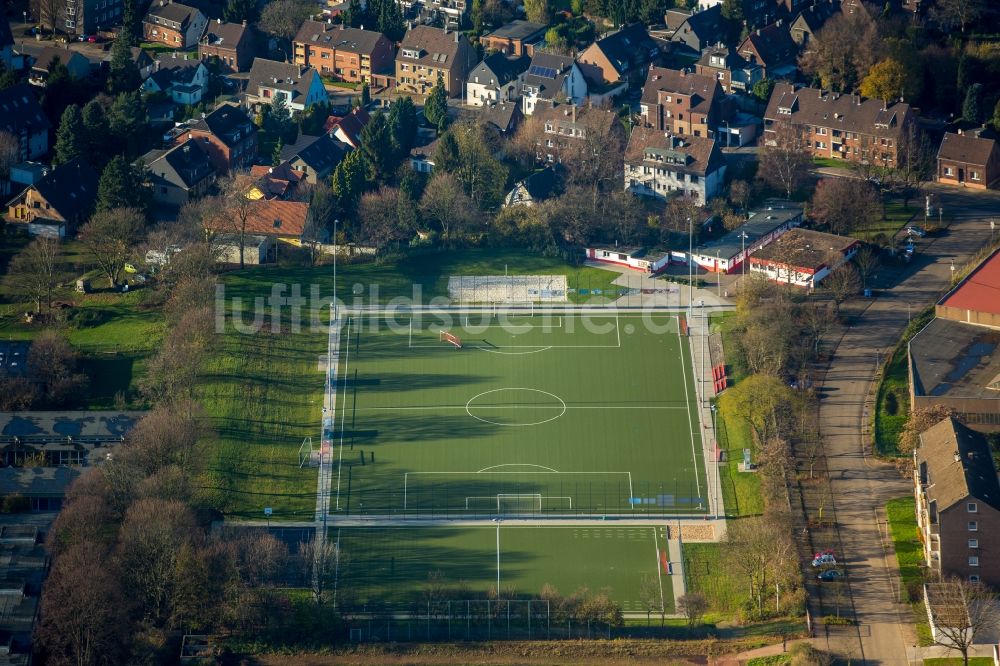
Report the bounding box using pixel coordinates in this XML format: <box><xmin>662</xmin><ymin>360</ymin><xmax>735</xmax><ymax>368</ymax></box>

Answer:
<box><xmin>331</xmin><ymin>314</ymin><xmax>706</xmax><ymax>517</ymax></box>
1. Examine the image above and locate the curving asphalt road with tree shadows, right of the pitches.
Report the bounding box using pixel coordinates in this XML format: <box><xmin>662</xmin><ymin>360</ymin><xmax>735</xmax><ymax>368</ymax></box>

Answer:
<box><xmin>820</xmin><ymin>179</ymin><xmax>1000</xmax><ymax>664</ymax></box>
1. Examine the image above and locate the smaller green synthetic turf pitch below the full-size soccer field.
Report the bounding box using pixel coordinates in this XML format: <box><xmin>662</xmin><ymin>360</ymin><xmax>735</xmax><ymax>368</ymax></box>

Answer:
<box><xmin>330</xmin><ymin>523</ymin><xmax>674</xmax><ymax>613</ymax></box>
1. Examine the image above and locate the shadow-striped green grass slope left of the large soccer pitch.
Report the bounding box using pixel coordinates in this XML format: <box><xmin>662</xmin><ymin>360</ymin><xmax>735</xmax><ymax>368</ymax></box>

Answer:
<box><xmin>197</xmin><ymin>314</ymin><xmax>326</xmax><ymax>520</ymax></box>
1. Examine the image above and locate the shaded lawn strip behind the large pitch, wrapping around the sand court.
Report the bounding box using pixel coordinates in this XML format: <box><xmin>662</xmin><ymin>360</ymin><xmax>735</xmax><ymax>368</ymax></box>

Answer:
<box><xmin>226</xmin><ymin>249</ymin><xmax>620</xmax><ymax>303</ymax></box>
